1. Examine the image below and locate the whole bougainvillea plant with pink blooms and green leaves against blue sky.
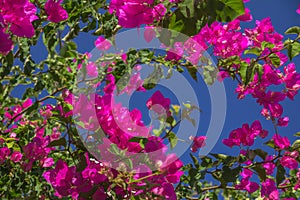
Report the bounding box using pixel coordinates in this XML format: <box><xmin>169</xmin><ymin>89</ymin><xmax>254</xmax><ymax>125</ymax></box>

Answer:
<box><xmin>0</xmin><ymin>0</ymin><xmax>300</xmax><ymax>200</ymax></box>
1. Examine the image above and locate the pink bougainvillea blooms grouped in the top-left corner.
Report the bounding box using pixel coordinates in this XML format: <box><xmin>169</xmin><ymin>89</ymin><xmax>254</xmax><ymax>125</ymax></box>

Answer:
<box><xmin>0</xmin><ymin>0</ymin><xmax>68</xmax><ymax>55</ymax></box>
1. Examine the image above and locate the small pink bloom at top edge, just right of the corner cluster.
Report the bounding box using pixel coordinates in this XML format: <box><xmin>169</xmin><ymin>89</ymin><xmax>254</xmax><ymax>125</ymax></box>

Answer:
<box><xmin>45</xmin><ymin>0</ymin><xmax>68</xmax><ymax>23</ymax></box>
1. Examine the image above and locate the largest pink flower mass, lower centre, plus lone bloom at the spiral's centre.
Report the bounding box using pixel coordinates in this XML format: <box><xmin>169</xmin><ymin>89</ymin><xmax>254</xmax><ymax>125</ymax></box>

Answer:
<box><xmin>44</xmin><ymin>68</ymin><xmax>183</xmax><ymax>199</ymax></box>
